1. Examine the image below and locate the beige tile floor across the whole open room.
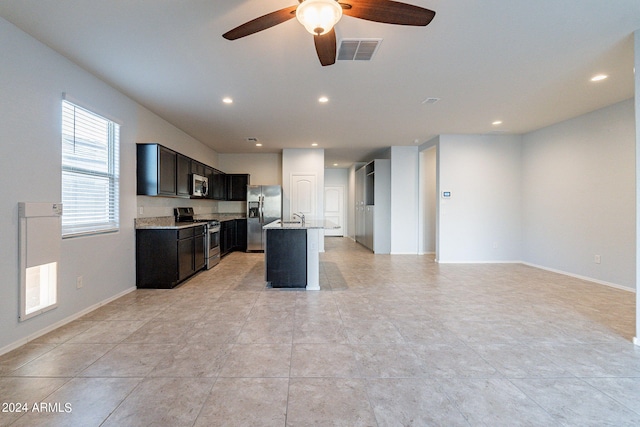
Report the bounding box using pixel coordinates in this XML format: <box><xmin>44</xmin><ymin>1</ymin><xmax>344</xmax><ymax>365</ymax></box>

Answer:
<box><xmin>0</xmin><ymin>238</ymin><xmax>640</xmax><ymax>427</ymax></box>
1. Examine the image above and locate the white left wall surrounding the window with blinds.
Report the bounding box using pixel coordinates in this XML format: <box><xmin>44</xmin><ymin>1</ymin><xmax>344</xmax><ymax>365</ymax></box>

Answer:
<box><xmin>0</xmin><ymin>19</ymin><xmax>215</xmax><ymax>353</ymax></box>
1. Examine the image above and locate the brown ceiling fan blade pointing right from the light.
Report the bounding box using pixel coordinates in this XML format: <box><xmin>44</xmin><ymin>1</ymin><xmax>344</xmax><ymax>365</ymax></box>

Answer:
<box><xmin>340</xmin><ymin>0</ymin><xmax>436</xmax><ymax>26</ymax></box>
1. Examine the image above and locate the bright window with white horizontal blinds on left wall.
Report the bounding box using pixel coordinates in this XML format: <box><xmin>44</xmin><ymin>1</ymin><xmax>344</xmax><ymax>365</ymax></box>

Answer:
<box><xmin>62</xmin><ymin>100</ymin><xmax>120</xmax><ymax>237</ymax></box>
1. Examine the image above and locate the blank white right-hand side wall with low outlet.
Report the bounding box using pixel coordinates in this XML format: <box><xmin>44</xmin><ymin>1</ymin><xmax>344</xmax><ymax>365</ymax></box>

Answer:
<box><xmin>522</xmin><ymin>100</ymin><xmax>636</xmax><ymax>289</ymax></box>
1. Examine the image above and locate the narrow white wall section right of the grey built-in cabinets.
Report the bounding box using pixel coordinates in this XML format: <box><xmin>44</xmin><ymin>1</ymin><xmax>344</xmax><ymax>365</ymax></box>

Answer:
<box><xmin>391</xmin><ymin>146</ymin><xmax>420</xmax><ymax>254</ymax></box>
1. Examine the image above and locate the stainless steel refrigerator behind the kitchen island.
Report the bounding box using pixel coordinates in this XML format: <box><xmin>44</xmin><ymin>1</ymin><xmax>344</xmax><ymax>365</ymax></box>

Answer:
<box><xmin>247</xmin><ymin>185</ymin><xmax>282</xmax><ymax>252</ymax></box>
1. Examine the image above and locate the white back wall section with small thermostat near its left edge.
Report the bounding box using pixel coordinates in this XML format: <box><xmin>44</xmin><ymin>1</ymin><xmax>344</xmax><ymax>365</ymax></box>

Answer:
<box><xmin>437</xmin><ymin>135</ymin><xmax>522</xmax><ymax>262</ymax></box>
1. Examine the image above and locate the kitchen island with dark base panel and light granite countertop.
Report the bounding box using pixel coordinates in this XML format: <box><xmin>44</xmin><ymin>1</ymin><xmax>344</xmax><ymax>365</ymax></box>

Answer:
<box><xmin>263</xmin><ymin>220</ymin><xmax>339</xmax><ymax>291</ymax></box>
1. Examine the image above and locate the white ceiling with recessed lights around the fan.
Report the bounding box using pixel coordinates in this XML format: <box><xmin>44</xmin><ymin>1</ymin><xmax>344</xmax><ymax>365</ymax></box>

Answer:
<box><xmin>0</xmin><ymin>0</ymin><xmax>640</xmax><ymax>166</ymax></box>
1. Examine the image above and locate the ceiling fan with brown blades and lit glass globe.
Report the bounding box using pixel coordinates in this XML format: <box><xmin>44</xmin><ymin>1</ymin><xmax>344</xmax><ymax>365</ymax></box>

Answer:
<box><xmin>222</xmin><ymin>0</ymin><xmax>436</xmax><ymax>66</ymax></box>
